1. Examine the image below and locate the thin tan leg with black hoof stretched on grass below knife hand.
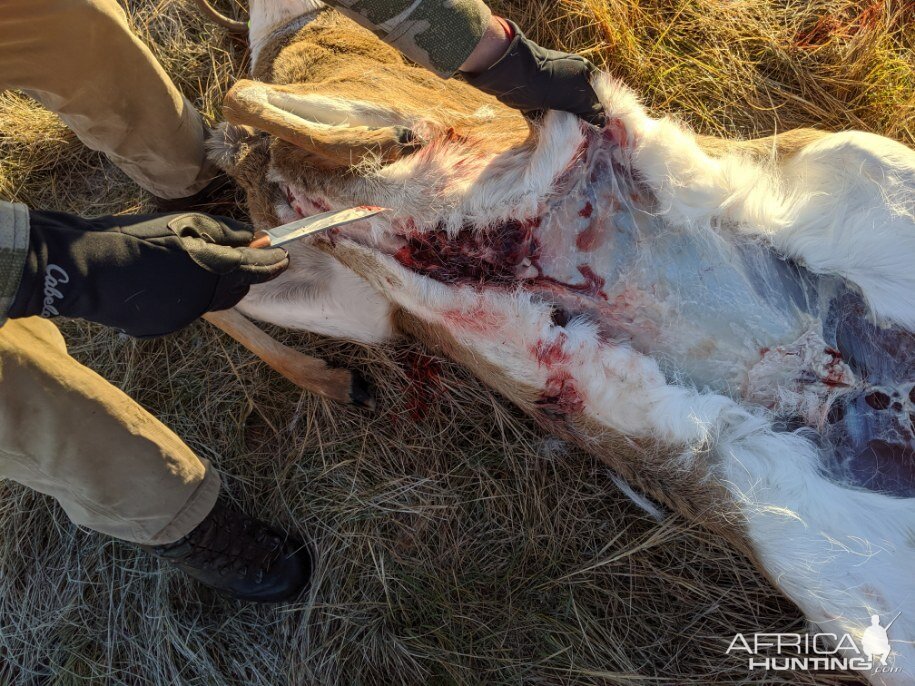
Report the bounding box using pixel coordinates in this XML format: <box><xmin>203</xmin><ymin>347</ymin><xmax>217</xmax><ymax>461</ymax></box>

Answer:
<box><xmin>203</xmin><ymin>309</ymin><xmax>375</xmax><ymax>409</ymax></box>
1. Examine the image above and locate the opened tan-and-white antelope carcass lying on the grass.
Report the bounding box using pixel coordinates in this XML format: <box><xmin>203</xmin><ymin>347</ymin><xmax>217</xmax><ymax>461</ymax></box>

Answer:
<box><xmin>213</xmin><ymin>0</ymin><xmax>915</xmax><ymax>684</ymax></box>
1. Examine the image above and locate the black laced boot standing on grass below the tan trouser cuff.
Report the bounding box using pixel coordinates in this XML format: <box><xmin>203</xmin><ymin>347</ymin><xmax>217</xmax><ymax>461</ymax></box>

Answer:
<box><xmin>142</xmin><ymin>501</ymin><xmax>312</xmax><ymax>603</ymax></box>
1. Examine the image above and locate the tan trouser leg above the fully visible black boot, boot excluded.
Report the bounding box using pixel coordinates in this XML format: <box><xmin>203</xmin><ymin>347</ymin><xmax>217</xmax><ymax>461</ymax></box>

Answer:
<box><xmin>0</xmin><ymin>317</ymin><xmax>219</xmax><ymax>545</ymax></box>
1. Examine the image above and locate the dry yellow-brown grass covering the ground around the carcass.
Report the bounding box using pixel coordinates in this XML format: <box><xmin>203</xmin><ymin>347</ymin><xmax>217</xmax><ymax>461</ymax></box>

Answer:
<box><xmin>0</xmin><ymin>0</ymin><xmax>915</xmax><ymax>686</ymax></box>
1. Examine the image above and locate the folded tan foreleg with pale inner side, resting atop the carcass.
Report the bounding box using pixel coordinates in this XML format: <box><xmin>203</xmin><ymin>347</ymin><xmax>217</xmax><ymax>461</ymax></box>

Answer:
<box><xmin>223</xmin><ymin>80</ymin><xmax>420</xmax><ymax>168</ymax></box>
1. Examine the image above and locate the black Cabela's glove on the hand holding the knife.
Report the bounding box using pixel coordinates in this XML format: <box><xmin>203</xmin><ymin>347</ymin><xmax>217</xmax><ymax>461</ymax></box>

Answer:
<box><xmin>9</xmin><ymin>211</ymin><xmax>289</xmax><ymax>337</ymax></box>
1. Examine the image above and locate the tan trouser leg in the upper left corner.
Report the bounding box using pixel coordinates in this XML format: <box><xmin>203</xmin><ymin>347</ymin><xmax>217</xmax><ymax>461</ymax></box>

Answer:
<box><xmin>0</xmin><ymin>0</ymin><xmax>215</xmax><ymax>198</ymax></box>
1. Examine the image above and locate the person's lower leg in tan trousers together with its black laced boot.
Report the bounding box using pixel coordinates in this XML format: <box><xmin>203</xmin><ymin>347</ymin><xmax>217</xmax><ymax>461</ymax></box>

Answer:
<box><xmin>0</xmin><ymin>317</ymin><xmax>312</xmax><ymax>602</ymax></box>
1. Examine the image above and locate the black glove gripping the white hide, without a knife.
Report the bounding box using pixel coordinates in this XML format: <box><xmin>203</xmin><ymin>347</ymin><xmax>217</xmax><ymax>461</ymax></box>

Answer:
<box><xmin>464</xmin><ymin>21</ymin><xmax>606</xmax><ymax>126</ymax></box>
